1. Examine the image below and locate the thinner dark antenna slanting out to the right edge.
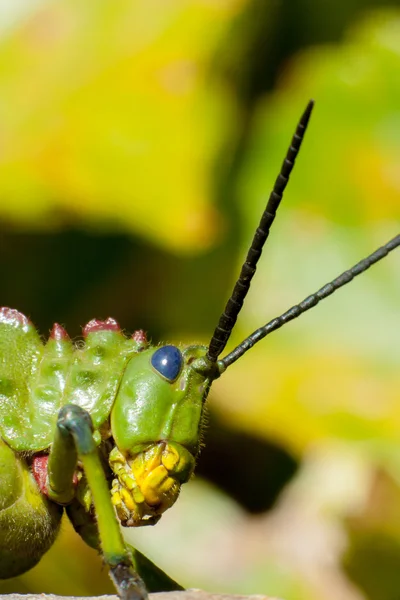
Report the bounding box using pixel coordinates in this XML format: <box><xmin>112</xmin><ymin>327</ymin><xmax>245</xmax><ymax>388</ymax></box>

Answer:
<box><xmin>218</xmin><ymin>235</ymin><xmax>400</xmax><ymax>370</ymax></box>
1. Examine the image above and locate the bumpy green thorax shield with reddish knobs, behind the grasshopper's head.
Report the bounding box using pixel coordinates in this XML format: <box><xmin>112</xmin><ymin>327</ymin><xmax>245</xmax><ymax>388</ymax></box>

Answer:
<box><xmin>0</xmin><ymin>308</ymin><xmax>142</xmax><ymax>452</ymax></box>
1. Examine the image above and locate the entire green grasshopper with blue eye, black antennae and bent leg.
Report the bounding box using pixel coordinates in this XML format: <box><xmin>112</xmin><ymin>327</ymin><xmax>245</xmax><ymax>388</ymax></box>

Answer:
<box><xmin>0</xmin><ymin>101</ymin><xmax>400</xmax><ymax>600</ymax></box>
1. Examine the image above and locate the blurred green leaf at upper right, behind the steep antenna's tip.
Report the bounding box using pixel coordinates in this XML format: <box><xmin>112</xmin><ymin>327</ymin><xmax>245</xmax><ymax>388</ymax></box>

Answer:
<box><xmin>242</xmin><ymin>10</ymin><xmax>400</xmax><ymax>225</ymax></box>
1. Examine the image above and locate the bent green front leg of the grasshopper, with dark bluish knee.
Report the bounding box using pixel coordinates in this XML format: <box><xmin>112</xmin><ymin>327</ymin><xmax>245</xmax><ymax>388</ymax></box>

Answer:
<box><xmin>48</xmin><ymin>404</ymin><xmax>147</xmax><ymax>600</ymax></box>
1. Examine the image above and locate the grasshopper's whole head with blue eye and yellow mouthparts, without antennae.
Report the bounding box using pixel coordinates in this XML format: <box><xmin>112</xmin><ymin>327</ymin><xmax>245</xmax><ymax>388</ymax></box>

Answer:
<box><xmin>110</xmin><ymin>345</ymin><xmax>210</xmax><ymax>526</ymax></box>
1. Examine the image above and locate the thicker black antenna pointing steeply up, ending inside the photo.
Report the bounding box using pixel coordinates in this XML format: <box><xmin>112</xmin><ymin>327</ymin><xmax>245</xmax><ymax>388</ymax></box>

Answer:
<box><xmin>207</xmin><ymin>100</ymin><xmax>314</xmax><ymax>362</ymax></box>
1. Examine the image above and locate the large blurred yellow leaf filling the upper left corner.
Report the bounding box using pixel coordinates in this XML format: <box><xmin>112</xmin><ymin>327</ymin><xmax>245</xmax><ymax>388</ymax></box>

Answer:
<box><xmin>0</xmin><ymin>0</ymin><xmax>248</xmax><ymax>251</ymax></box>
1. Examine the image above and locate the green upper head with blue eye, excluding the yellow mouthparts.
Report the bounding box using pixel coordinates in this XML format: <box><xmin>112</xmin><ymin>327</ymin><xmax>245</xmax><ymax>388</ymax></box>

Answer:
<box><xmin>111</xmin><ymin>345</ymin><xmax>216</xmax><ymax>455</ymax></box>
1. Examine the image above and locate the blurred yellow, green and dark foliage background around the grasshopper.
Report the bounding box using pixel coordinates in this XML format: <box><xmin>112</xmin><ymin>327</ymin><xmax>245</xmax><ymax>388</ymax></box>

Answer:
<box><xmin>0</xmin><ymin>0</ymin><xmax>400</xmax><ymax>600</ymax></box>
